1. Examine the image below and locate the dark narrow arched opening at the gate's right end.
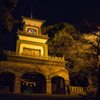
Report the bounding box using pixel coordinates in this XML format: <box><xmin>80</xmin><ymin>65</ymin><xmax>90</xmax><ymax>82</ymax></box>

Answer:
<box><xmin>52</xmin><ymin>76</ymin><xmax>65</xmax><ymax>94</ymax></box>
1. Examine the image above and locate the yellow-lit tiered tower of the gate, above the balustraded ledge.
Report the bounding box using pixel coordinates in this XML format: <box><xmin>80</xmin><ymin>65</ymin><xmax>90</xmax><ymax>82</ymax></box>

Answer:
<box><xmin>16</xmin><ymin>17</ymin><xmax>48</xmax><ymax>57</ymax></box>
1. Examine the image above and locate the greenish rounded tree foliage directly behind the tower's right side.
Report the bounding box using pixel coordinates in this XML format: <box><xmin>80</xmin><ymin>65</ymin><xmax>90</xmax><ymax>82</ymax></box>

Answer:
<box><xmin>42</xmin><ymin>23</ymin><xmax>81</xmax><ymax>56</ymax></box>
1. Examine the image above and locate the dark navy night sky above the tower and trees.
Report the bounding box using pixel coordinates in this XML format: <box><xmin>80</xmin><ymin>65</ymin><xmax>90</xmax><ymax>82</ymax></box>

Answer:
<box><xmin>0</xmin><ymin>0</ymin><xmax>100</xmax><ymax>50</ymax></box>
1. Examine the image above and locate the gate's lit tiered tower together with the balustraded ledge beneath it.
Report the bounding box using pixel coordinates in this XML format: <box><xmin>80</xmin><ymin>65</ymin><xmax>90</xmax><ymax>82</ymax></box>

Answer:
<box><xmin>0</xmin><ymin>17</ymin><xmax>67</xmax><ymax>67</ymax></box>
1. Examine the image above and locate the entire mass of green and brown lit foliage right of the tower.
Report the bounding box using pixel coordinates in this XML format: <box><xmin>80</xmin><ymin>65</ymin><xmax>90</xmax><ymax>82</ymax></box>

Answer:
<box><xmin>42</xmin><ymin>23</ymin><xmax>97</xmax><ymax>86</ymax></box>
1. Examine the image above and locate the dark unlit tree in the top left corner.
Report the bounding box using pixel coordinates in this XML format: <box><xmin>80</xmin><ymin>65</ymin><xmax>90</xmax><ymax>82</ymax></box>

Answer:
<box><xmin>0</xmin><ymin>0</ymin><xmax>18</xmax><ymax>37</ymax></box>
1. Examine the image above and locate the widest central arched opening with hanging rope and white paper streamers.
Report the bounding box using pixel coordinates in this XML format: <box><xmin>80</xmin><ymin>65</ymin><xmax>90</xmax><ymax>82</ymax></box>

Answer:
<box><xmin>21</xmin><ymin>72</ymin><xmax>46</xmax><ymax>93</ymax></box>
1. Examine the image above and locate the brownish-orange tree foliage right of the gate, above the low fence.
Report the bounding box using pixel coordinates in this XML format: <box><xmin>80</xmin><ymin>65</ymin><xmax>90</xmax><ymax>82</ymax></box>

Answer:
<box><xmin>68</xmin><ymin>36</ymin><xmax>97</xmax><ymax>86</ymax></box>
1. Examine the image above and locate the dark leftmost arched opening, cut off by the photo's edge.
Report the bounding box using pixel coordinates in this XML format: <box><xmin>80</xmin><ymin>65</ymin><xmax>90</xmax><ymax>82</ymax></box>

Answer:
<box><xmin>0</xmin><ymin>72</ymin><xmax>15</xmax><ymax>92</ymax></box>
